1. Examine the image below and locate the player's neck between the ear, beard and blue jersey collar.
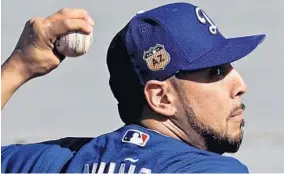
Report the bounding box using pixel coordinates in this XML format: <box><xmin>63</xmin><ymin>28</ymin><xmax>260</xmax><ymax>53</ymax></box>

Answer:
<box><xmin>141</xmin><ymin>116</ymin><xmax>207</xmax><ymax>150</ymax></box>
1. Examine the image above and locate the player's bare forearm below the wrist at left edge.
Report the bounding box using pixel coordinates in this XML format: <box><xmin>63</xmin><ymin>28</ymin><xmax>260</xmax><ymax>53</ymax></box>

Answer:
<box><xmin>1</xmin><ymin>55</ymin><xmax>29</xmax><ymax>109</ymax></box>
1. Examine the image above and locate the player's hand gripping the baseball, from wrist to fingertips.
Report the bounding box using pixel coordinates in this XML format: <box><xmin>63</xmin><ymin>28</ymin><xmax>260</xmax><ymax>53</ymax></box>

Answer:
<box><xmin>11</xmin><ymin>9</ymin><xmax>94</xmax><ymax>78</ymax></box>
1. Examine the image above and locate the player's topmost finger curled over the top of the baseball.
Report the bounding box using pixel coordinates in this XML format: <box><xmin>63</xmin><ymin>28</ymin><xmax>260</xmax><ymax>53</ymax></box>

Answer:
<box><xmin>47</xmin><ymin>8</ymin><xmax>94</xmax><ymax>25</ymax></box>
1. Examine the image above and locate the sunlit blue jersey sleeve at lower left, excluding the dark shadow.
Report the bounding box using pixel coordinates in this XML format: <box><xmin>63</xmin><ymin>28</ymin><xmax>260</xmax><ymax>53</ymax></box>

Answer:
<box><xmin>1</xmin><ymin>144</ymin><xmax>71</xmax><ymax>173</ymax></box>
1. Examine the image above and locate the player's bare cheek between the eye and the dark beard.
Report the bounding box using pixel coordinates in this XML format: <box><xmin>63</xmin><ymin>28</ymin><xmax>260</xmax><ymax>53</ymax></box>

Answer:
<box><xmin>188</xmin><ymin>88</ymin><xmax>230</xmax><ymax>133</ymax></box>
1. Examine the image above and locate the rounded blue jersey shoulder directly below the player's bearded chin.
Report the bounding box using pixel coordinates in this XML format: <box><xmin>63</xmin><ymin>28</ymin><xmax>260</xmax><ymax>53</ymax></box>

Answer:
<box><xmin>158</xmin><ymin>150</ymin><xmax>249</xmax><ymax>173</ymax></box>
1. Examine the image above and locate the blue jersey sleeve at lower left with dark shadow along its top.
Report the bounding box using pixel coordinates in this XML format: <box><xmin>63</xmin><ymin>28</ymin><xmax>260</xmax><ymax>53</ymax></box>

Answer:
<box><xmin>1</xmin><ymin>138</ymin><xmax>90</xmax><ymax>173</ymax></box>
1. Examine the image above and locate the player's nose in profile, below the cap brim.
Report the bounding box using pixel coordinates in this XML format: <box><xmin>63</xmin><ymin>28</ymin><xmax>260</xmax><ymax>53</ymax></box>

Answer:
<box><xmin>231</xmin><ymin>69</ymin><xmax>247</xmax><ymax>98</ymax></box>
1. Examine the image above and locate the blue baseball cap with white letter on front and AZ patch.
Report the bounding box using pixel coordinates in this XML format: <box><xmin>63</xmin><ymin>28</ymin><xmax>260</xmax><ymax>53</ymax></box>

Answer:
<box><xmin>107</xmin><ymin>3</ymin><xmax>265</xmax><ymax>110</ymax></box>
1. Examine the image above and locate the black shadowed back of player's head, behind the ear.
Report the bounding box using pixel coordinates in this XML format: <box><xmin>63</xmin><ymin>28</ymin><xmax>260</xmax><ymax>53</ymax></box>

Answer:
<box><xmin>107</xmin><ymin>26</ymin><xmax>146</xmax><ymax>124</ymax></box>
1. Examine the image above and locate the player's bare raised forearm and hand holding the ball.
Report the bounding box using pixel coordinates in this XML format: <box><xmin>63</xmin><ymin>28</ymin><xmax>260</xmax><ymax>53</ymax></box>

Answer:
<box><xmin>1</xmin><ymin>9</ymin><xmax>94</xmax><ymax>109</ymax></box>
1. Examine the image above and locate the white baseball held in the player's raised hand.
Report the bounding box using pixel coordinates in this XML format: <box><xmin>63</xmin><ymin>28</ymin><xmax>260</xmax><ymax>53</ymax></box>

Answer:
<box><xmin>55</xmin><ymin>31</ymin><xmax>93</xmax><ymax>57</ymax></box>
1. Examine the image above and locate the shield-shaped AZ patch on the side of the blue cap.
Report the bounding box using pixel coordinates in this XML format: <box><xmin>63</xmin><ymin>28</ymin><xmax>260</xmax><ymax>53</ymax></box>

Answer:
<box><xmin>143</xmin><ymin>44</ymin><xmax>171</xmax><ymax>71</ymax></box>
